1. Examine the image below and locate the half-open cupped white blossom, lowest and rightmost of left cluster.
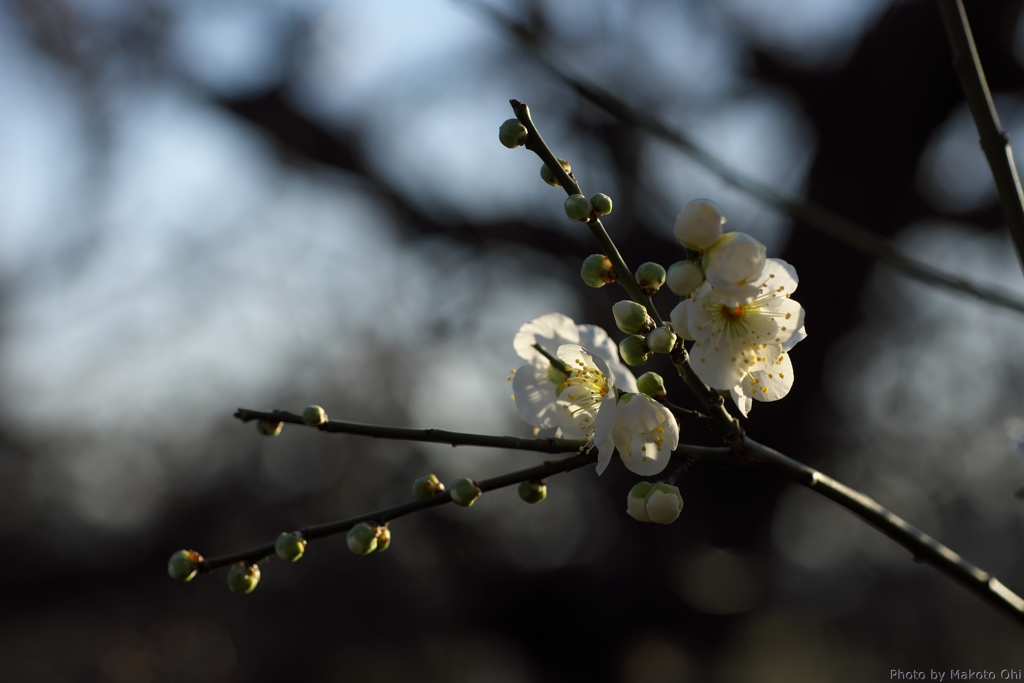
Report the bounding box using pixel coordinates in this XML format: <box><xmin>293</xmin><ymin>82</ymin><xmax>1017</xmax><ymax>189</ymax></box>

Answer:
<box><xmin>594</xmin><ymin>393</ymin><xmax>679</xmax><ymax>476</ymax></box>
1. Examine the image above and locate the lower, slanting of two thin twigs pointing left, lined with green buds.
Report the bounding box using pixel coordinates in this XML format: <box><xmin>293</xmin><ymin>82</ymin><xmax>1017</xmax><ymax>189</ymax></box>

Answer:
<box><xmin>201</xmin><ymin>448</ymin><xmax>597</xmax><ymax>571</ymax></box>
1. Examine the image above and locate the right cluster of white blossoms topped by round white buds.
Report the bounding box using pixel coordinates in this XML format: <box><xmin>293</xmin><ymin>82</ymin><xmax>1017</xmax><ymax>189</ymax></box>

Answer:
<box><xmin>669</xmin><ymin>200</ymin><xmax>807</xmax><ymax>416</ymax></box>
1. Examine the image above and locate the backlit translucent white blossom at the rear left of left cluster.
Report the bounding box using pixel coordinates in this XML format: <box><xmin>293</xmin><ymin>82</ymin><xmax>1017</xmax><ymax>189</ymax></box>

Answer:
<box><xmin>512</xmin><ymin>313</ymin><xmax>637</xmax><ymax>435</ymax></box>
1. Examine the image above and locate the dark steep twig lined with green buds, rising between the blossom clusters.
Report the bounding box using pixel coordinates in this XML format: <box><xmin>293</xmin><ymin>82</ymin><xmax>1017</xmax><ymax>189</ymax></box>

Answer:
<box><xmin>509</xmin><ymin>99</ymin><xmax>742</xmax><ymax>444</ymax></box>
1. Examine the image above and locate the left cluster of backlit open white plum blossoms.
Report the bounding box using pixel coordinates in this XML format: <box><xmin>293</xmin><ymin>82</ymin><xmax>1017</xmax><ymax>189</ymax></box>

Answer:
<box><xmin>512</xmin><ymin>313</ymin><xmax>679</xmax><ymax>476</ymax></box>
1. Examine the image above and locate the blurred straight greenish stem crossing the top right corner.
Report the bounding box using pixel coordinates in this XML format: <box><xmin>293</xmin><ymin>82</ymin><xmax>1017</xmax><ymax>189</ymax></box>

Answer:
<box><xmin>939</xmin><ymin>0</ymin><xmax>1024</xmax><ymax>274</ymax></box>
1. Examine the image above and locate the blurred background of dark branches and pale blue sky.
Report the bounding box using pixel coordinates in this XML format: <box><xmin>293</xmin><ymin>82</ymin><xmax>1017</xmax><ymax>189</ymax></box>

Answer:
<box><xmin>6</xmin><ymin>0</ymin><xmax>1024</xmax><ymax>683</ymax></box>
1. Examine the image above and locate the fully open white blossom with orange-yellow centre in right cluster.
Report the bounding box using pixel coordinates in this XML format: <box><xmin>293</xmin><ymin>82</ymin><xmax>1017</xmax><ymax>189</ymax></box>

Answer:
<box><xmin>672</xmin><ymin>259</ymin><xmax>806</xmax><ymax>395</ymax></box>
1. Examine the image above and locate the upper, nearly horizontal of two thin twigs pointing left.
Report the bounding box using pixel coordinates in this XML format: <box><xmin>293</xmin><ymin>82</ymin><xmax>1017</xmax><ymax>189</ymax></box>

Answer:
<box><xmin>234</xmin><ymin>408</ymin><xmax>587</xmax><ymax>453</ymax></box>
